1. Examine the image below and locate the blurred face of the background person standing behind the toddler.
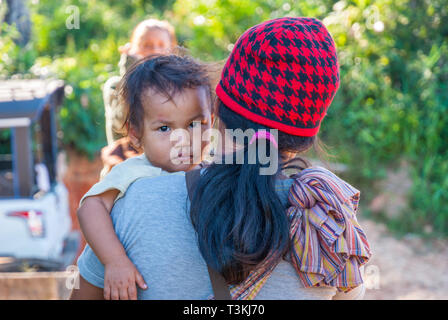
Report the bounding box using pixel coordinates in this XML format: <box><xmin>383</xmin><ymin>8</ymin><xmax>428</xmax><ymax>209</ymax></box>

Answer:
<box><xmin>129</xmin><ymin>28</ymin><xmax>171</xmax><ymax>59</ymax></box>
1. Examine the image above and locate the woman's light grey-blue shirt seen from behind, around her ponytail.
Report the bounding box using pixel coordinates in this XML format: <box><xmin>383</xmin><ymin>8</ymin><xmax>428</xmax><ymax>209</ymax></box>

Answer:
<box><xmin>78</xmin><ymin>173</ymin><xmax>360</xmax><ymax>300</ymax></box>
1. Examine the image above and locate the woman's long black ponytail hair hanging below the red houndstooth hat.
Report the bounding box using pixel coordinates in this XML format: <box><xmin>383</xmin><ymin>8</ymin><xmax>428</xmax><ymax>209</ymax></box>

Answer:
<box><xmin>190</xmin><ymin>100</ymin><xmax>316</xmax><ymax>284</ymax></box>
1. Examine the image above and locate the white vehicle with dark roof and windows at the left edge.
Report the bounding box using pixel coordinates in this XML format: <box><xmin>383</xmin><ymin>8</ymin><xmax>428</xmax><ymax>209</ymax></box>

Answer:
<box><xmin>0</xmin><ymin>80</ymin><xmax>79</xmax><ymax>271</ymax></box>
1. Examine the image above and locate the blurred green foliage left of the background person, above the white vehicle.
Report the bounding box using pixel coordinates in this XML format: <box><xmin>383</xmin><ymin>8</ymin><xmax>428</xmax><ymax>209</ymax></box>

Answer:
<box><xmin>0</xmin><ymin>0</ymin><xmax>172</xmax><ymax>158</ymax></box>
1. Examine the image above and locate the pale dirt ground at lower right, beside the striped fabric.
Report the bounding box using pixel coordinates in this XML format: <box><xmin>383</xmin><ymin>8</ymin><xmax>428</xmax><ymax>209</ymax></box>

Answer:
<box><xmin>359</xmin><ymin>217</ymin><xmax>448</xmax><ymax>300</ymax></box>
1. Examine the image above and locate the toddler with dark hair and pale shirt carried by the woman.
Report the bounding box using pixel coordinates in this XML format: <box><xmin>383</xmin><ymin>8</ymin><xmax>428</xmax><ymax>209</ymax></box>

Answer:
<box><xmin>78</xmin><ymin>55</ymin><xmax>213</xmax><ymax>299</ymax></box>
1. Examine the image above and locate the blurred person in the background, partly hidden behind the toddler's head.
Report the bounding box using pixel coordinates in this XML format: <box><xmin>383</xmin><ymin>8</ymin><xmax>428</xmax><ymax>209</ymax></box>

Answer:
<box><xmin>102</xmin><ymin>19</ymin><xmax>177</xmax><ymax>170</ymax></box>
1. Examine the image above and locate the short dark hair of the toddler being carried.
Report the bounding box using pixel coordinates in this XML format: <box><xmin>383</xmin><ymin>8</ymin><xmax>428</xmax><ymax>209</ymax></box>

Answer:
<box><xmin>118</xmin><ymin>54</ymin><xmax>212</xmax><ymax>138</ymax></box>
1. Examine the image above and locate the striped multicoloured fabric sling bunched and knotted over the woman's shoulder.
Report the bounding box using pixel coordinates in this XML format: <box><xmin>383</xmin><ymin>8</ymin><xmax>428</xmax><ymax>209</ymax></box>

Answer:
<box><xmin>226</xmin><ymin>166</ymin><xmax>371</xmax><ymax>300</ymax></box>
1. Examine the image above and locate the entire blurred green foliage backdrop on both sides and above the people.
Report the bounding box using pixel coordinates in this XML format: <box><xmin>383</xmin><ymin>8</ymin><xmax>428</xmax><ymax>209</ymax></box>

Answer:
<box><xmin>0</xmin><ymin>0</ymin><xmax>448</xmax><ymax>237</ymax></box>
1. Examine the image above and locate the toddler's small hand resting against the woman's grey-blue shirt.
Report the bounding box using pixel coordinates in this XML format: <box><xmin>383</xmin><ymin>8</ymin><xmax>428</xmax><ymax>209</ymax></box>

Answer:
<box><xmin>104</xmin><ymin>257</ymin><xmax>148</xmax><ymax>300</ymax></box>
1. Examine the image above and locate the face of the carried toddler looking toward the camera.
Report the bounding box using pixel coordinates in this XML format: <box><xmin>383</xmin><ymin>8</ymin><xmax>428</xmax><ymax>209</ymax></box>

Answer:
<box><xmin>133</xmin><ymin>87</ymin><xmax>212</xmax><ymax>172</ymax></box>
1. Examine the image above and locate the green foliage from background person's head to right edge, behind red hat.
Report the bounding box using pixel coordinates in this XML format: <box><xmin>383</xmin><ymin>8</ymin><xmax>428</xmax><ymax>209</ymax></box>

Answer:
<box><xmin>173</xmin><ymin>0</ymin><xmax>448</xmax><ymax>234</ymax></box>
